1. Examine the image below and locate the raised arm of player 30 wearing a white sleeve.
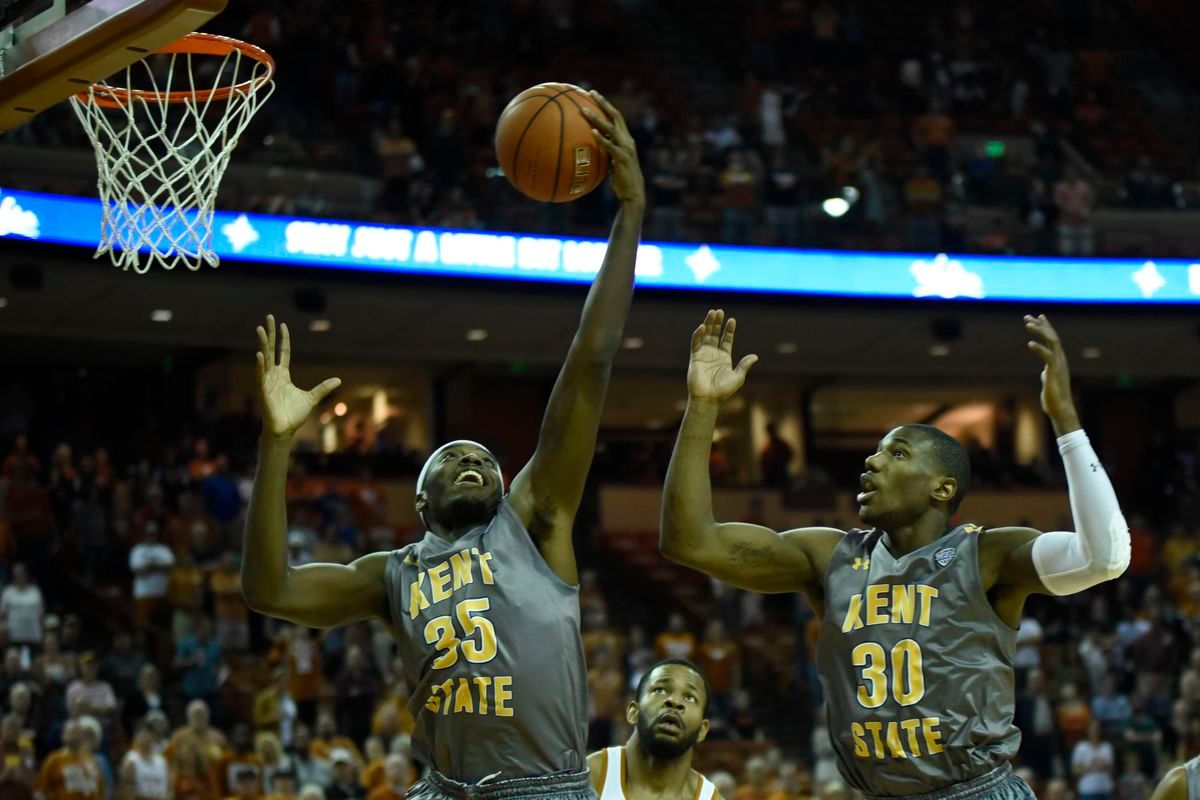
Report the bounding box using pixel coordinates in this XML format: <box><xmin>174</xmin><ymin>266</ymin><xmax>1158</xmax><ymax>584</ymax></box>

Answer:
<box><xmin>984</xmin><ymin>314</ymin><xmax>1129</xmax><ymax>606</ymax></box>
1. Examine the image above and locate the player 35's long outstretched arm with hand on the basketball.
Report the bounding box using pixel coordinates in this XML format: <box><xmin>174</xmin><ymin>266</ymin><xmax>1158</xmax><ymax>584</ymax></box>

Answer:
<box><xmin>509</xmin><ymin>92</ymin><xmax>646</xmax><ymax>584</ymax></box>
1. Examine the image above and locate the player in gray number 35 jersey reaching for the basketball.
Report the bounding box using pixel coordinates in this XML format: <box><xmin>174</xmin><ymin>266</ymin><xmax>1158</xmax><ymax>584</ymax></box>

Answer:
<box><xmin>242</xmin><ymin>89</ymin><xmax>646</xmax><ymax>800</ymax></box>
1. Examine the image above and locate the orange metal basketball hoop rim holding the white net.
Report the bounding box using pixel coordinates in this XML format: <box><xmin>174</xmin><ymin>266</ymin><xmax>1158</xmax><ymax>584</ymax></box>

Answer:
<box><xmin>76</xmin><ymin>34</ymin><xmax>275</xmax><ymax>108</ymax></box>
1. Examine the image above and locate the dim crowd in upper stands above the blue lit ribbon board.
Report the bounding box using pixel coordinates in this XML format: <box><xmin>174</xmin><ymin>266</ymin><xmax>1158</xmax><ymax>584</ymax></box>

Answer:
<box><xmin>13</xmin><ymin>0</ymin><xmax>1200</xmax><ymax>255</ymax></box>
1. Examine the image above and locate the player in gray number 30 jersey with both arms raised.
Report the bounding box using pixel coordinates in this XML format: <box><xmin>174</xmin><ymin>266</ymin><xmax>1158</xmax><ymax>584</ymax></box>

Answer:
<box><xmin>661</xmin><ymin>311</ymin><xmax>1129</xmax><ymax>800</ymax></box>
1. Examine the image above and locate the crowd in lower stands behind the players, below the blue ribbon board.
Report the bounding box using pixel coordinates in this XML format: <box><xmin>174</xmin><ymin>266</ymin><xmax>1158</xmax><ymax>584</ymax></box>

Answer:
<box><xmin>0</xmin><ymin>383</ymin><xmax>1200</xmax><ymax>800</ymax></box>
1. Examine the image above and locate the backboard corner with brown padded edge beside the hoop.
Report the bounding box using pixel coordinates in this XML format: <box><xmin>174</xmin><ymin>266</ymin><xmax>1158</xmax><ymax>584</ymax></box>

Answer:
<box><xmin>0</xmin><ymin>0</ymin><xmax>228</xmax><ymax>133</ymax></box>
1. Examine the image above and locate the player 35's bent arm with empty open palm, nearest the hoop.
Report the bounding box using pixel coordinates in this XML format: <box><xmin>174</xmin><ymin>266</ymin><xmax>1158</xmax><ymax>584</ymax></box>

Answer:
<box><xmin>241</xmin><ymin>317</ymin><xmax>389</xmax><ymax>627</ymax></box>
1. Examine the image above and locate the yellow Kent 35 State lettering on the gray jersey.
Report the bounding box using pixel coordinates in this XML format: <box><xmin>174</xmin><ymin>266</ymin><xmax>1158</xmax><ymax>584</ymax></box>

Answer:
<box><xmin>406</xmin><ymin>547</ymin><xmax>512</xmax><ymax>717</ymax></box>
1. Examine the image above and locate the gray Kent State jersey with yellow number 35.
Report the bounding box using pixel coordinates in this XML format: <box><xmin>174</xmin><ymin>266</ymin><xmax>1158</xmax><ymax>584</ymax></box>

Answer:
<box><xmin>386</xmin><ymin>498</ymin><xmax>588</xmax><ymax>783</ymax></box>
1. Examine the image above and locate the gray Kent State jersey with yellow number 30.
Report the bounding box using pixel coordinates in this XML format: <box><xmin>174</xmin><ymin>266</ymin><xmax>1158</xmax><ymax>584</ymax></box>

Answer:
<box><xmin>817</xmin><ymin>525</ymin><xmax>1021</xmax><ymax>796</ymax></box>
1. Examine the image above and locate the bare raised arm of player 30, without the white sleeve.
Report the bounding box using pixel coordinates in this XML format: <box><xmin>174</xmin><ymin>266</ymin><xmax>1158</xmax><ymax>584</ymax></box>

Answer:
<box><xmin>659</xmin><ymin>311</ymin><xmax>842</xmax><ymax>593</ymax></box>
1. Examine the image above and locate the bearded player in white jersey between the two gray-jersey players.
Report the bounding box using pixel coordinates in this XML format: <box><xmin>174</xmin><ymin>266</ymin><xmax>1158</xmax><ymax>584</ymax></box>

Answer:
<box><xmin>588</xmin><ymin>658</ymin><xmax>721</xmax><ymax>800</ymax></box>
